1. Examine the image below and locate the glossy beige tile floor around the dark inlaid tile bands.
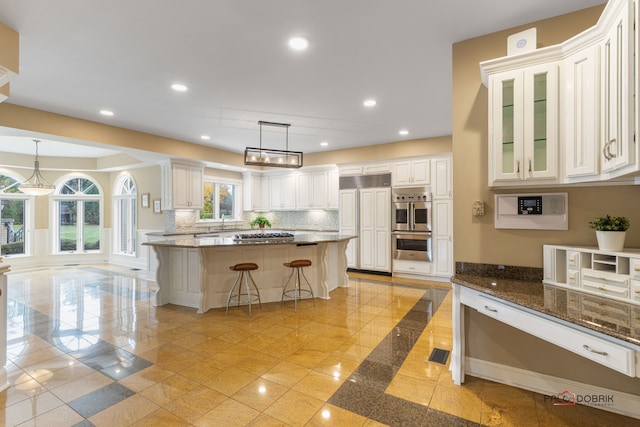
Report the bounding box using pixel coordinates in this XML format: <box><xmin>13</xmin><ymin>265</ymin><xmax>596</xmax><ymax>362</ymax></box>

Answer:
<box><xmin>0</xmin><ymin>265</ymin><xmax>640</xmax><ymax>427</ymax></box>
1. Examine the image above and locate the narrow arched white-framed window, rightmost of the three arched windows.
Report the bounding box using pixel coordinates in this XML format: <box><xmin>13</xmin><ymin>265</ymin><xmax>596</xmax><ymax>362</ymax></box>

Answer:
<box><xmin>113</xmin><ymin>175</ymin><xmax>136</xmax><ymax>255</ymax></box>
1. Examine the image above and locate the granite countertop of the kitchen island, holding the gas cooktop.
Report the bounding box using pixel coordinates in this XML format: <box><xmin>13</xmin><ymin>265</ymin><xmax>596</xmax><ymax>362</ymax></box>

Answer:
<box><xmin>143</xmin><ymin>233</ymin><xmax>356</xmax><ymax>248</ymax></box>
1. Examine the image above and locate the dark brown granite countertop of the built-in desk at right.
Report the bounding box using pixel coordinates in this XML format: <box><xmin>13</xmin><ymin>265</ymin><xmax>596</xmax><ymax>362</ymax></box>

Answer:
<box><xmin>451</xmin><ymin>274</ymin><xmax>640</xmax><ymax>345</ymax></box>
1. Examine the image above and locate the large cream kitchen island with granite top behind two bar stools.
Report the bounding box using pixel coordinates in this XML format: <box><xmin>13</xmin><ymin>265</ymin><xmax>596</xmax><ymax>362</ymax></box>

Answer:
<box><xmin>144</xmin><ymin>233</ymin><xmax>356</xmax><ymax>313</ymax></box>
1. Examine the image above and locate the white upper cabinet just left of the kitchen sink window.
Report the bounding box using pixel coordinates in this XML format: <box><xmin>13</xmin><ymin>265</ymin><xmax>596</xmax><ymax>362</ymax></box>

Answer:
<box><xmin>161</xmin><ymin>160</ymin><xmax>204</xmax><ymax>210</ymax></box>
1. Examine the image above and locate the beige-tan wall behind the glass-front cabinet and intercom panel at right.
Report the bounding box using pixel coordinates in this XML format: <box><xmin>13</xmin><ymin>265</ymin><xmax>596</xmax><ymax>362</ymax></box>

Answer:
<box><xmin>453</xmin><ymin>6</ymin><xmax>640</xmax><ymax>267</ymax></box>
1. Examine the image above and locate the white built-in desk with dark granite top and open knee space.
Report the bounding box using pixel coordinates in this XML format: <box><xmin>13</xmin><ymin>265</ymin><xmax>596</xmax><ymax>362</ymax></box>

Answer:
<box><xmin>450</xmin><ymin>274</ymin><xmax>640</xmax><ymax>418</ymax></box>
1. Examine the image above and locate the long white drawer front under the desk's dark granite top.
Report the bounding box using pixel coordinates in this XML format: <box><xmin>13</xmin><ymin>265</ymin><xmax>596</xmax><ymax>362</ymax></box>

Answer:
<box><xmin>465</xmin><ymin>294</ymin><xmax>635</xmax><ymax>377</ymax></box>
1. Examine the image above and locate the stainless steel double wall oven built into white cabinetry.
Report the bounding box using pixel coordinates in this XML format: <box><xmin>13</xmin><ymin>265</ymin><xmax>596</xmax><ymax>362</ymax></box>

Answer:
<box><xmin>391</xmin><ymin>187</ymin><xmax>432</xmax><ymax>262</ymax></box>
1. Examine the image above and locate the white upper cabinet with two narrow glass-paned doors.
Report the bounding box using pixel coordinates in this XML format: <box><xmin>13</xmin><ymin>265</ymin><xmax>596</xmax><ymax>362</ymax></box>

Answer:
<box><xmin>489</xmin><ymin>62</ymin><xmax>558</xmax><ymax>186</ymax></box>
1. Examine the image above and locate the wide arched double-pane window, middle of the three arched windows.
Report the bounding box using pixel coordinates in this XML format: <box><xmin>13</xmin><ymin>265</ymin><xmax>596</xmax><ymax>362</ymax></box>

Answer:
<box><xmin>54</xmin><ymin>177</ymin><xmax>102</xmax><ymax>252</ymax></box>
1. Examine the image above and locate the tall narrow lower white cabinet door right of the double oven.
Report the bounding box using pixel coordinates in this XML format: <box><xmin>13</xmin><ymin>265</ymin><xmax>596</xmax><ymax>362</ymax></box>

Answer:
<box><xmin>431</xmin><ymin>200</ymin><xmax>453</xmax><ymax>277</ymax></box>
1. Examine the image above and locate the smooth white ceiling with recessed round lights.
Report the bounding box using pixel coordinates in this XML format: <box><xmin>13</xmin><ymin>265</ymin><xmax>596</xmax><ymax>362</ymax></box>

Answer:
<box><xmin>0</xmin><ymin>0</ymin><xmax>602</xmax><ymax>157</ymax></box>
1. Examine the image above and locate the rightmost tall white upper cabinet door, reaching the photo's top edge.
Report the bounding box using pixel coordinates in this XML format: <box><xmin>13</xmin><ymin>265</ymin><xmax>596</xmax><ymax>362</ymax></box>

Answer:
<box><xmin>601</xmin><ymin>0</ymin><xmax>637</xmax><ymax>176</ymax></box>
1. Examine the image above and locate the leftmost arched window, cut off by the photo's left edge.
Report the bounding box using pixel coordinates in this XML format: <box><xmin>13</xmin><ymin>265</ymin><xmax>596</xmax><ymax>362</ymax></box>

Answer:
<box><xmin>0</xmin><ymin>172</ymin><xmax>30</xmax><ymax>256</ymax></box>
